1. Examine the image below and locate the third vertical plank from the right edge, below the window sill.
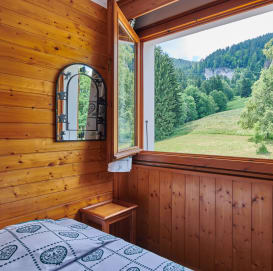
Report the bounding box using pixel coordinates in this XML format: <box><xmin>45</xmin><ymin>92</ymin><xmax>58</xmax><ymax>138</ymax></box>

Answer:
<box><xmin>215</xmin><ymin>177</ymin><xmax>232</xmax><ymax>271</ymax></box>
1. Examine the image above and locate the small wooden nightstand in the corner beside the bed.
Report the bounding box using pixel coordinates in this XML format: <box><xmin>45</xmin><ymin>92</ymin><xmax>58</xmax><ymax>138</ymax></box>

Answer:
<box><xmin>80</xmin><ymin>200</ymin><xmax>138</xmax><ymax>244</ymax></box>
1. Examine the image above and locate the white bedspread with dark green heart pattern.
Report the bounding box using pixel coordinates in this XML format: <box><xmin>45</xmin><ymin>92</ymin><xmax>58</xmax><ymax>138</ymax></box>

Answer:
<box><xmin>0</xmin><ymin>219</ymin><xmax>190</xmax><ymax>271</ymax></box>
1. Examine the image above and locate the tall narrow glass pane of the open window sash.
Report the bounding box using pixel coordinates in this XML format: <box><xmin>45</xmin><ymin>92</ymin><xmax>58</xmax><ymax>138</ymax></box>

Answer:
<box><xmin>118</xmin><ymin>22</ymin><xmax>136</xmax><ymax>151</ymax></box>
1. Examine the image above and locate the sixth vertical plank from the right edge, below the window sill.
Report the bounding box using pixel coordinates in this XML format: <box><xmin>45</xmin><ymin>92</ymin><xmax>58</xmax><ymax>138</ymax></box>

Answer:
<box><xmin>172</xmin><ymin>173</ymin><xmax>186</xmax><ymax>263</ymax></box>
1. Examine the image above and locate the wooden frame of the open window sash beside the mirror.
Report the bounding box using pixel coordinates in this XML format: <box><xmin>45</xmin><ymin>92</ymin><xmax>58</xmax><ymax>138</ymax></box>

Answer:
<box><xmin>107</xmin><ymin>0</ymin><xmax>143</xmax><ymax>162</ymax></box>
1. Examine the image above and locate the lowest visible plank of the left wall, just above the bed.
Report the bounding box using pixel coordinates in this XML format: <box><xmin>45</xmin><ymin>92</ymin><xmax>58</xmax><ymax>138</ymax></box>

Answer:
<box><xmin>0</xmin><ymin>192</ymin><xmax>112</xmax><ymax>229</ymax></box>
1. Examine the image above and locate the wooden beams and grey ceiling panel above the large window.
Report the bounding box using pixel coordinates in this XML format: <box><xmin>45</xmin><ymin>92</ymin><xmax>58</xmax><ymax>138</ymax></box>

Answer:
<box><xmin>118</xmin><ymin>0</ymin><xmax>273</xmax><ymax>41</ymax></box>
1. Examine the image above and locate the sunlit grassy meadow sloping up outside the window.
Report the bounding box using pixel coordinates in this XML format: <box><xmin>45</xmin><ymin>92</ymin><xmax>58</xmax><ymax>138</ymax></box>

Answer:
<box><xmin>155</xmin><ymin>97</ymin><xmax>273</xmax><ymax>159</ymax></box>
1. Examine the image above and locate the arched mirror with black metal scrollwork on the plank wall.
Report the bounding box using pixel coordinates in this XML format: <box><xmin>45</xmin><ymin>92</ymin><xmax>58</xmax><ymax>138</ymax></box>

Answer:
<box><xmin>56</xmin><ymin>63</ymin><xmax>106</xmax><ymax>141</ymax></box>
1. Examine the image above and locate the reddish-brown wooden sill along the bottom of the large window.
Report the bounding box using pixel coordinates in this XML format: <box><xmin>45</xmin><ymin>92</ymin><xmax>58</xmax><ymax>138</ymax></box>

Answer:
<box><xmin>134</xmin><ymin>151</ymin><xmax>273</xmax><ymax>180</ymax></box>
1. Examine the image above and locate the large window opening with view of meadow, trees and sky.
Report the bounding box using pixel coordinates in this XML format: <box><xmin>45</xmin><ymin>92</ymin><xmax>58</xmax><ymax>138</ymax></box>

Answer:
<box><xmin>144</xmin><ymin>12</ymin><xmax>273</xmax><ymax>159</ymax></box>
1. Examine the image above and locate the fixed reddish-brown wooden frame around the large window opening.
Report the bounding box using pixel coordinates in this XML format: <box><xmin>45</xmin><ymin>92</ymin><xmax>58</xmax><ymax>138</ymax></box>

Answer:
<box><xmin>134</xmin><ymin>0</ymin><xmax>273</xmax><ymax>179</ymax></box>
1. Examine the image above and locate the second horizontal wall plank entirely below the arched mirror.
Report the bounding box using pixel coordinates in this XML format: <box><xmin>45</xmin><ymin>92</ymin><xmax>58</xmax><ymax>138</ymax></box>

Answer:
<box><xmin>0</xmin><ymin>150</ymin><xmax>103</xmax><ymax>172</ymax></box>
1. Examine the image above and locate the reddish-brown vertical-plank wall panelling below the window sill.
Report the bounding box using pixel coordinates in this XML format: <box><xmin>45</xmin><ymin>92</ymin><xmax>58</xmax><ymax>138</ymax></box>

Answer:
<box><xmin>115</xmin><ymin>165</ymin><xmax>273</xmax><ymax>271</ymax></box>
